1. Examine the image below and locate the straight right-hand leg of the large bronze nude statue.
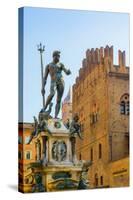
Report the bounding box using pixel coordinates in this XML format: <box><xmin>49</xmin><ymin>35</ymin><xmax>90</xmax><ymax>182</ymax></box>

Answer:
<box><xmin>55</xmin><ymin>82</ymin><xmax>64</xmax><ymax>118</ymax></box>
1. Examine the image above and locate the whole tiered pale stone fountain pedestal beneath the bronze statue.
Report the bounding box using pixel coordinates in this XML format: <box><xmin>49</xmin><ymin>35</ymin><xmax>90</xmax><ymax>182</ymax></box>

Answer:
<box><xmin>31</xmin><ymin>119</ymin><xmax>82</xmax><ymax>191</ymax></box>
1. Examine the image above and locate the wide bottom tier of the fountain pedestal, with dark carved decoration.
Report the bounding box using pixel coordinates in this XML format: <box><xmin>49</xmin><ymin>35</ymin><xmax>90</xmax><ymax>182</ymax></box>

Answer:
<box><xmin>31</xmin><ymin>166</ymin><xmax>82</xmax><ymax>192</ymax></box>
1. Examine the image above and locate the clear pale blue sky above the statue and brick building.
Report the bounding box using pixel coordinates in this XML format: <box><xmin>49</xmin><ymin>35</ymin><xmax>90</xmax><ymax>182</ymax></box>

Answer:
<box><xmin>23</xmin><ymin>7</ymin><xmax>129</xmax><ymax>122</ymax></box>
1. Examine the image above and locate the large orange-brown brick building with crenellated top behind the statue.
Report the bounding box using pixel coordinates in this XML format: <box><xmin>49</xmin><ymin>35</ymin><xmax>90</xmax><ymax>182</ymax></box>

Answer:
<box><xmin>72</xmin><ymin>46</ymin><xmax>129</xmax><ymax>188</ymax></box>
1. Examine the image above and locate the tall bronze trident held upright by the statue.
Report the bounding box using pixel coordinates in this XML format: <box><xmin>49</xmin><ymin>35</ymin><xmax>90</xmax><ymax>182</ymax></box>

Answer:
<box><xmin>37</xmin><ymin>43</ymin><xmax>45</xmax><ymax>108</ymax></box>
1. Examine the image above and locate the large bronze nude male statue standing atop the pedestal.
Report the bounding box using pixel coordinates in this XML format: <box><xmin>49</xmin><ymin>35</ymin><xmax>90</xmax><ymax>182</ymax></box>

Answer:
<box><xmin>41</xmin><ymin>51</ymin><xmax>71</xmax><ymax>118</ymax></box>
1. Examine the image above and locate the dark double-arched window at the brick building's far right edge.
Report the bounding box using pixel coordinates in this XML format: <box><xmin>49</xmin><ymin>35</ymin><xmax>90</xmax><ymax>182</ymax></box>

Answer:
<box><xmin>120</xmin><ymin>94</ymin><xmax>129</xmax><ymax>115</ymax></box>
